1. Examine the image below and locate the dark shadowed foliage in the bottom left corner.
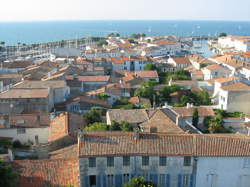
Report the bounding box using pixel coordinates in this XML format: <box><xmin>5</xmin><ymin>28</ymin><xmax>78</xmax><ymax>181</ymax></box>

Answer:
<box><xmin>0</xmin><ymin>160</ymin><xmax>18</xmax><ymax>187</ymax></box>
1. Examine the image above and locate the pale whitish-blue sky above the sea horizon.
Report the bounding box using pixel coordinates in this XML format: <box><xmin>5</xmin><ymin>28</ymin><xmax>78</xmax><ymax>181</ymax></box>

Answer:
<box><xmin>0</xmin><ymin>0</ymin><xmax>250</xmax><ymax>21</ymax></box>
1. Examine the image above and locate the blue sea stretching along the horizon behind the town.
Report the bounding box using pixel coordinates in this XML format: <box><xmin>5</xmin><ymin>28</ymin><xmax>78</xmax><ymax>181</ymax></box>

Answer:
<box><xmin>0</xmin><ymin>20</ymin><xmax>250</xmax><ymax>45</ymax></box>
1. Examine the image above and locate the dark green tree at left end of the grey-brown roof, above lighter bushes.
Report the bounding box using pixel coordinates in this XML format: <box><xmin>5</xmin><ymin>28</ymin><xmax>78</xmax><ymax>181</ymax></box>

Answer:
<box><xmin>83</xmin><ymin>107</ymin><xmax>106</xmax><ymax>124</ymax></box>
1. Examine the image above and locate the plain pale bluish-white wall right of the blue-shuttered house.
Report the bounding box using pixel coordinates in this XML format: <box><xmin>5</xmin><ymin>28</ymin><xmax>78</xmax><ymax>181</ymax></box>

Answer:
<box><xmin>196</xmin><ymin>157</ymin><xmax>250</xmax><ymax>187</ymax></box>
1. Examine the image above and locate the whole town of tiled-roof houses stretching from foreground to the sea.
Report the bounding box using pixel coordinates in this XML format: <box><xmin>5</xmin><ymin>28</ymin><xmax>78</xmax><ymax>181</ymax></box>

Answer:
<box><xmin>0</xmin><ymin>33</ymin><xmax>250</xmax><ymax>187</ymax></box>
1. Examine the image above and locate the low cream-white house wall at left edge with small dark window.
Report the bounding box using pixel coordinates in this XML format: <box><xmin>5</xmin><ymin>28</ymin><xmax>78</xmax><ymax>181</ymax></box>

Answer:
<box><xmin>0</xmin><ymin>127</ymin><xmax>49</xmax><ymax>144</ymax></box>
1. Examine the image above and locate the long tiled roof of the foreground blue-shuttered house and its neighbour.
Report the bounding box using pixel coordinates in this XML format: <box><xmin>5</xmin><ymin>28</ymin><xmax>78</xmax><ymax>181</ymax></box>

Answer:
<box><xmin>79</xmin><ymin>132</ymin><xmax>250</xmax><ymax>157</ymax></box>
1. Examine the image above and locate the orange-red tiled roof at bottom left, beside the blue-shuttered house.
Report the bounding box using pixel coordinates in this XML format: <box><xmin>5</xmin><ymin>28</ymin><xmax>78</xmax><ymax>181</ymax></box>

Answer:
<box><xmin>12</xmin><ymin>159</ymin><xmax>80</xmax><ymax>187</ymax></box>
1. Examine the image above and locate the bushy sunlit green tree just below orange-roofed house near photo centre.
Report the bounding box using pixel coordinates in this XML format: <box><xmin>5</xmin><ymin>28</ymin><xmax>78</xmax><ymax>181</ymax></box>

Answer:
<box><xmin>134</xmin><ymin>81</ymin><xmax>157</xmax><ymax>103</ymax></box>
